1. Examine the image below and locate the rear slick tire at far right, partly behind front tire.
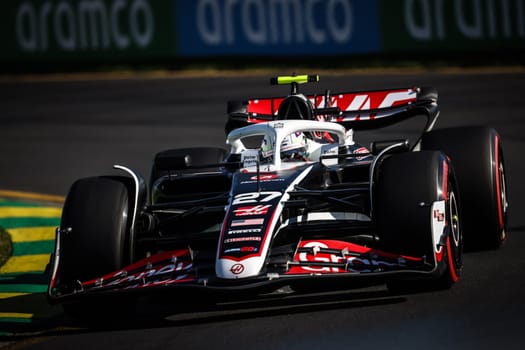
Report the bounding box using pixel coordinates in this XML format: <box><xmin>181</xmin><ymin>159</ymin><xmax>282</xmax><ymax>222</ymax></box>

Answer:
<box><xmin>421</xmin><ymin>126</ymin><xmax>508</xmax><ymax>250</ymax></box>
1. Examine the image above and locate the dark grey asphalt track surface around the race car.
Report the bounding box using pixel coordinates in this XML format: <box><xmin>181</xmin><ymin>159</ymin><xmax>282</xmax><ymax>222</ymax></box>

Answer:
<box><xmin>0</xmin><ymin>71</ymin><xmax>525</xmax><ymax>350</ymax></box>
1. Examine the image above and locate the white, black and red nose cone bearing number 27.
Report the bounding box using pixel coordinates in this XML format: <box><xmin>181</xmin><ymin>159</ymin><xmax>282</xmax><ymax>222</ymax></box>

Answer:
<box><xmin>215</xmin><ymin>166</ymin><xmax>311</xmax><ymax>279</ymax></box>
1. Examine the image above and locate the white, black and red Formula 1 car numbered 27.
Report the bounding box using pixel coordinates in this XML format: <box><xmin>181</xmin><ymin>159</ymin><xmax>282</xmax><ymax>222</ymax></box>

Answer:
<box><xmin>48</xmin><ymin>75</ymin><xmax>508</xmax><ymax>315</ymax></box>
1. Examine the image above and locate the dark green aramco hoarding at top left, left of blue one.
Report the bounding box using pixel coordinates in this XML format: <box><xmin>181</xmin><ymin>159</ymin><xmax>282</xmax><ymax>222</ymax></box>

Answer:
<box><xmin>0</xmin><ymin>0</ymin><xmax>175</xmax><ymax>61</ymax></box>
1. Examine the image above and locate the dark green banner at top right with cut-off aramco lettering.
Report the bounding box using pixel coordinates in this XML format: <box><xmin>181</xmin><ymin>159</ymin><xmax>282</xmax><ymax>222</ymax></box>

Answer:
<box><xmin>380</xmin><ymin>0</ymin><xmax>525</xmax><ymax>52</ymax></box>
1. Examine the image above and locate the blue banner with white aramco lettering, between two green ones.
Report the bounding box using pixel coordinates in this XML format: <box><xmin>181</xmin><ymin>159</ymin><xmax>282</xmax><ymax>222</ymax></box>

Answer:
<box><xmin>175</xmin><ymin>0</ymin><xmax>380</xmax><ymax>57</ymax></box>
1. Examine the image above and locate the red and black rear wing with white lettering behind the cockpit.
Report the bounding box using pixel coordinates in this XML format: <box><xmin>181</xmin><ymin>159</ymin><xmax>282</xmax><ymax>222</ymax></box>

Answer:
<box><xmin>226</xmin><ymin>87</ymin><xmax>439</xmax><ymax>133</ymax></box>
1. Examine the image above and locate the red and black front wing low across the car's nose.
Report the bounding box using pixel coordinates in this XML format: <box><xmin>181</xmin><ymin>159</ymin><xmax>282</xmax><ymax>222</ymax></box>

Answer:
<box><xmin>48</xmin><ymin>230</ymin><xmax>437</xmax><ymax>302</ymax></box>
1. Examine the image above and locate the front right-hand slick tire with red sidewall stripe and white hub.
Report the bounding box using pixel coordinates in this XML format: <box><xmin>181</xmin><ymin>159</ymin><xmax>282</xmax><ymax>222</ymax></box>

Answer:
<box><xmin>373</xmin><ymin>151</ymin><xmax>463</xmax><ymax>292</ymax></box>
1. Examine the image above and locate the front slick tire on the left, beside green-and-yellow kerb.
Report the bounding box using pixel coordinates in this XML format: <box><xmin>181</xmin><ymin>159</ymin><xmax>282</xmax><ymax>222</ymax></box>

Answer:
<box><xmin>58</xmin><ymin>177</ymin><xmax>132</xmax><ymax>318</ymax></box>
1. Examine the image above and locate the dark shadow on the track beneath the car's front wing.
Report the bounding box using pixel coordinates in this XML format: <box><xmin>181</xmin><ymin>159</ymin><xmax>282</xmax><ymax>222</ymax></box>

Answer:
<box><xmin>0</xmin><ymin>287</ymin><xmax>406</xmax><ymax>341</ymax></box>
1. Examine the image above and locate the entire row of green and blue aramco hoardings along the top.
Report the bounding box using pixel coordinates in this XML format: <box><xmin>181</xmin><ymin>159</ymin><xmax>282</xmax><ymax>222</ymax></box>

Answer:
<box><xmin>0</xmin><ymin>0</ymin><xmax>525</xmax><ymax>63</ymax></box>
